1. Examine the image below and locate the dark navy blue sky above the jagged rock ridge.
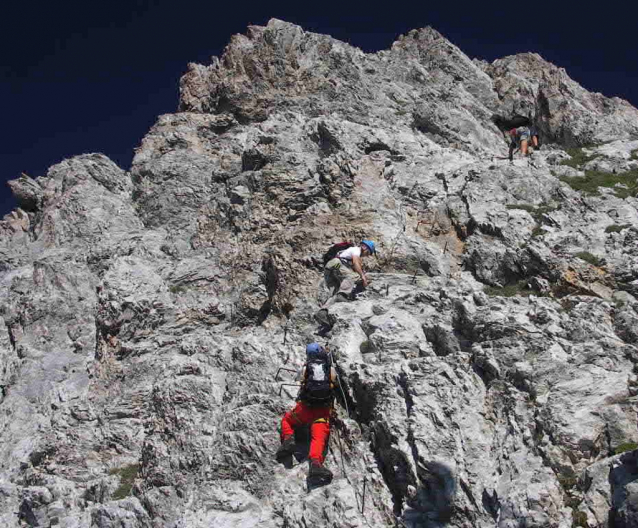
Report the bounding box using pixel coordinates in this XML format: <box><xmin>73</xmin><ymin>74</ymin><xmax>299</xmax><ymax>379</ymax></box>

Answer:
<box><xmin>0</xmin><ymin>0</ymin><xmax>638</xmax><ymax>215</ymax></box>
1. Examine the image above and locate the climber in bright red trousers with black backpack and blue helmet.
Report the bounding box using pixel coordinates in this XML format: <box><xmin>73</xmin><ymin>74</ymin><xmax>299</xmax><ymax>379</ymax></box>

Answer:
<box><xmin>275</xmin><ymin>343</ymin><xmax>337</xmax><ymax>484</ymax></box>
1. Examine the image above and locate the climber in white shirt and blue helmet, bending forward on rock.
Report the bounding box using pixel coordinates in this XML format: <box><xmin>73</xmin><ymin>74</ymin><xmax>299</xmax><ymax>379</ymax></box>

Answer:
<box><xmin>324</xmin><ymin>240</ymin><xmax>376</xmax><ymax>302</ymax></box>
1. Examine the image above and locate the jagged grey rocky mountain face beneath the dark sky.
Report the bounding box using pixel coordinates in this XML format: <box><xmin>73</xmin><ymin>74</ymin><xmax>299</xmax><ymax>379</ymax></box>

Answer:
<box><xmin>0</xmin><ymin>20</ymin><xmax>638</xmax><ymax>528</ymax></box>
